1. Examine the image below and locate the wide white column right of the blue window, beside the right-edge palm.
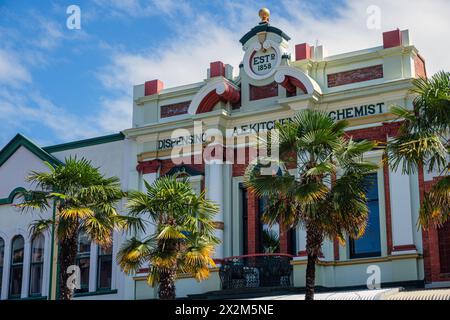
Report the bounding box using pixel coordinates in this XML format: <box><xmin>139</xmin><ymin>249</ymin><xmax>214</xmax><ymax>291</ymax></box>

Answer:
<box><xmin>389</xmin><ymin>164</ymin><xmax>416</xmax><ymax>254</ymax></box>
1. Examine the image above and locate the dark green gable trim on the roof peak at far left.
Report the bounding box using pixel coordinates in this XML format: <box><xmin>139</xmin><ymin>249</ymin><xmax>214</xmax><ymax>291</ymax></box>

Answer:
<box><xmin>0</xmin><ymin>133</ymin><xmax>62</xmax><ymax>166</ymax></box>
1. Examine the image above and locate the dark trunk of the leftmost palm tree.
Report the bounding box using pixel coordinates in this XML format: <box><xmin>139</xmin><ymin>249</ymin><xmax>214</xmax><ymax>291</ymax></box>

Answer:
<box><xmin>58</xmin><ymin>236</ymin><xmax>79</xmax><ymax>300</ymax></box>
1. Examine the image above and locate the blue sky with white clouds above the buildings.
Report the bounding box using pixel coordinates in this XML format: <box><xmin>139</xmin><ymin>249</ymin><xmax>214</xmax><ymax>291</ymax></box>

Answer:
<box><xmin>0</xmin><ymin>0</ymin><xmax>450</xmax><ymax>148</ymax></box>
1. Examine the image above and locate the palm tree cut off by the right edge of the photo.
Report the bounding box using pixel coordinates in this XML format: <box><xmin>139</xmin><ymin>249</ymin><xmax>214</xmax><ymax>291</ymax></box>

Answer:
<box><xmin>387</xmin><ymin>71</ymin><xmax>450</xmax><ymax>228</ymax></box>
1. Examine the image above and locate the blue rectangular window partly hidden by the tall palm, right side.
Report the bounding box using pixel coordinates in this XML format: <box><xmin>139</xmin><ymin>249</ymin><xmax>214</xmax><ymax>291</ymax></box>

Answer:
<box><xmin>350</xmin><ymin>174</ymin><xmax>381</xmax><ymax>259</ymax></box>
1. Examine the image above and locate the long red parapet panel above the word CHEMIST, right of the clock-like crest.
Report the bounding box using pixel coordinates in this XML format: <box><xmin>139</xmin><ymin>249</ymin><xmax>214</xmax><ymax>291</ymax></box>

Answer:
<box><xmin>327</xmin><ymin>64</ymin><xmax>384</xmax><ymax>88</ymax></box>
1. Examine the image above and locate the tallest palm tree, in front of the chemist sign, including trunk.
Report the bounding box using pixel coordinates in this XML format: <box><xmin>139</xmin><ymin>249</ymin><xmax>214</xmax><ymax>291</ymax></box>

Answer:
<box><xmin>245</xmin><ymin>110</ymin><xmax>377</xmax><ymax>300</ymax></box>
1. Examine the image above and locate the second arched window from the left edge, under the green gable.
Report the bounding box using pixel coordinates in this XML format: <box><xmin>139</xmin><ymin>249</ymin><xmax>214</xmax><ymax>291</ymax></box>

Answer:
<box><xmin>9</xmin><ymin>236</ymin><xmax>25</xmax><ymax>299</ymax></box>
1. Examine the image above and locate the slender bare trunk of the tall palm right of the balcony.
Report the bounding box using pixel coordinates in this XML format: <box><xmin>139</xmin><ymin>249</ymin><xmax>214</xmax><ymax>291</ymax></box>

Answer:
<box><xmin>305</xmin><ymin>225</ymin><xmax>323</xmax><ymax>300</ymax></box>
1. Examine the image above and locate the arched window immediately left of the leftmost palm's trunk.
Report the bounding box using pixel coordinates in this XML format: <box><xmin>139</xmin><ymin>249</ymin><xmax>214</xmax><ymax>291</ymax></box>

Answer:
<box><xmin>29</xmin><ymin>235</ymin><xmax>44</xmax><ymax>296</ymax></box>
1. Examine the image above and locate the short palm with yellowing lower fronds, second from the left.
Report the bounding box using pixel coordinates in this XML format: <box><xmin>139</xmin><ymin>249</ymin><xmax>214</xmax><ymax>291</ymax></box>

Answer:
<box><xmin>117</xmin><ymin>176</ymin><xmax>219</xmax><ymax>300</ymax></box>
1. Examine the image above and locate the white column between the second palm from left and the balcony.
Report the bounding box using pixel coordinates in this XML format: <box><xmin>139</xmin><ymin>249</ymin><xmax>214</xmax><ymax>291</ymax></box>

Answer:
<box><xmin>206</xmin><ymin>161</ymin><xmax>224</xmax><ymax>259</ymax></box>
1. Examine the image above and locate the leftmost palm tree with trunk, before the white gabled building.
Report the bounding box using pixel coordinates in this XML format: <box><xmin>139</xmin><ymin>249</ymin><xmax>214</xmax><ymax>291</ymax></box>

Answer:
<box><xmin>18</xmin><ymin>158</ymin><xmax>133</xmax><ymax>300</ymax></box>
